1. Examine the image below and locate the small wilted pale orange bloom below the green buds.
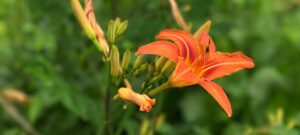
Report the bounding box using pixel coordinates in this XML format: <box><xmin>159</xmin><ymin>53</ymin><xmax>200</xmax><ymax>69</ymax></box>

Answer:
<box><xmin>118</xmin><ymin>88</ymin><xmax>155</xmax><ymax>112</ymax></box>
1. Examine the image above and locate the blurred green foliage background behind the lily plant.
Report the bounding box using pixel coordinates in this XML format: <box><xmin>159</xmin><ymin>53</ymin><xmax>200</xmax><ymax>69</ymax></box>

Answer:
<box><xmin>0</xmin><ymin>0</ymin><xmax>300</xmax><ymax>135</ymax></box>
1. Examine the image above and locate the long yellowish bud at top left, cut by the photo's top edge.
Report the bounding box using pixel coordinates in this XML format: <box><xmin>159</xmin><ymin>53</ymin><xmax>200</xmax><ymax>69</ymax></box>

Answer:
<box><xmin>71</xmin><ymin>0</ymin><xmax>96</xmax><ymax>40</ymax></box>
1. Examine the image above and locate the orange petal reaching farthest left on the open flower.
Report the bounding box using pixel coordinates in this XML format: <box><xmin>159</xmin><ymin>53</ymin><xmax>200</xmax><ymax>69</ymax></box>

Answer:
<box><xmin>135</xmin><ymin>41</ymin><xmax>179</xmax><ymax>63</ymax></box>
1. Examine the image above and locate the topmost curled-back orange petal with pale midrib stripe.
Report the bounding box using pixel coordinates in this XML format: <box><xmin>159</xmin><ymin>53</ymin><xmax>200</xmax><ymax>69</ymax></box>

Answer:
<box><xmin>156</xmin><ymin>29</ymin><xmax>200</xmax><ymax>63</ymax></box>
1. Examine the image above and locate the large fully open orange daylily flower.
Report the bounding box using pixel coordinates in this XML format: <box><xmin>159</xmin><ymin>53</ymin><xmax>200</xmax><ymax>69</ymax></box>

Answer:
<box><xmin>136</xmin><ymin>29</ymin><xmax>254</xmax><ymax>117</ymax></box>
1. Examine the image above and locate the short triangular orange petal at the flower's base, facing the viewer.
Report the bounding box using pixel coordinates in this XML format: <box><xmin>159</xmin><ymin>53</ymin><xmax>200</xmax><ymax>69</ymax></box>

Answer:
<box><xmin>169</xmin><ymin>57</ymin><xmax>202</xmax><ymax>87</ymax></box>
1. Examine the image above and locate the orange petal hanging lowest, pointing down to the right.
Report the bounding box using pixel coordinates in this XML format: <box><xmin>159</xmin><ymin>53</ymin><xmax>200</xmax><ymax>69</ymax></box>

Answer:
<box><xmin>199</xmin><ymin>81</ymin><xmax>232</xmax><ymax>117</ymax></box>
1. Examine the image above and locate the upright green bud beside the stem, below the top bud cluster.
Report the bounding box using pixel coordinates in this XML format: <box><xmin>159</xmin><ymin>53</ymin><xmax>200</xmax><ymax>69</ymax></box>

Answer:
<box><xmin>110</xmin><ymin>45</ymin><xmax>122</xmax><ymax>77</ymax></box>
